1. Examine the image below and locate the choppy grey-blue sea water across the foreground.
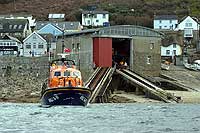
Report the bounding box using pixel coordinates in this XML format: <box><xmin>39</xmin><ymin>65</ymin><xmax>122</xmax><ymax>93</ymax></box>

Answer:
<box><xmin>0</xmin><ymin>103</ymin><xmax>200</xmax><ymax>133</ymax></box>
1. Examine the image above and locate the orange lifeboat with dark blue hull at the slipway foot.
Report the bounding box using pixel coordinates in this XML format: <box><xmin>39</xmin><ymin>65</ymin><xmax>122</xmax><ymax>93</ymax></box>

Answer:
<box><xmin>41</xmin><ymin>55</ymin><xmax>91</xmax><ymax>106</ymax></box>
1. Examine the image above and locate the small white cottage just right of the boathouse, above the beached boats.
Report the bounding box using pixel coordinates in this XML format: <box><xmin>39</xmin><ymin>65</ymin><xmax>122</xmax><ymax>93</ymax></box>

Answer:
<box><xmin>161</xmin><ymin>43</ymin><xmax>182</xmax><ymax>58</ymax></box>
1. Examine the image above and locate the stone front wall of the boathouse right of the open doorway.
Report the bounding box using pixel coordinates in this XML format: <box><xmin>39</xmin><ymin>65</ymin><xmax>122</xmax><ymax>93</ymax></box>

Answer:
<box><xmin>131</xmin><ymin>37</ymin><xmax>161</xmax><ymax>76</ymax></box>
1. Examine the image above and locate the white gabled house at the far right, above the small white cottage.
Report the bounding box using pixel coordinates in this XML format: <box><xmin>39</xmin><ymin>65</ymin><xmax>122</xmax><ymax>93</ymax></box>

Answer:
<box><xmin>175</xmin><ymin>16</ymin><xmax>199</xmax><ymax>38</ymax></box>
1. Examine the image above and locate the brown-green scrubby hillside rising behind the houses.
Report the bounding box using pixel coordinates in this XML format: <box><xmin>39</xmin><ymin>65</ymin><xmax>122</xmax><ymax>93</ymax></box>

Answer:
<box><xmin>0</xmin><ymin>0</ymin><xmax>200</xmax><ymax>27</ymax></box>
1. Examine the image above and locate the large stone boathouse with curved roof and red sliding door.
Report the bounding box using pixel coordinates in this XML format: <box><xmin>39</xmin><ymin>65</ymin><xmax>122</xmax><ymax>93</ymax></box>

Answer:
<box><xmin>56</xmin><ymin>25</ymin><xmax>162</xmax><ymax>76</ymax></box>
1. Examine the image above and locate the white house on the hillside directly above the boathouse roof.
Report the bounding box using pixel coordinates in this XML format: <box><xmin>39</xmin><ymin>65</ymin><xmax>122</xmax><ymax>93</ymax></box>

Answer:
<box><xmin>82</xmin><ymin>11</ymin><xmax>109</xmax><ymax>26</ymax></box>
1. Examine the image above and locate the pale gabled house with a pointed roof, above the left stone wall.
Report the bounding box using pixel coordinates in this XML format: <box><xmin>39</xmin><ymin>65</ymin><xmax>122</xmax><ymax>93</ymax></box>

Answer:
<box><xmin>23</xmin><ymin>32</ymin><xmax>47</xmax><ymax>57</ymax></box>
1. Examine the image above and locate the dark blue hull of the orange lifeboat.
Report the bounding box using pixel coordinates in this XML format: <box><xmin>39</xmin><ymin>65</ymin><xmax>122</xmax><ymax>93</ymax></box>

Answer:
<box><xmin>41</xmin><ymin>87</ymin><xmax>91</xmax><ymax>106</ymax></box>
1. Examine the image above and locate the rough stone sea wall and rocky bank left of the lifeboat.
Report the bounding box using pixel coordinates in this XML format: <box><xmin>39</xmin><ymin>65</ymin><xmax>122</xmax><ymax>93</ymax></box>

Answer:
<box><xmin>0</xmin><ymin>57</ymin><xmax>48</xmax><ymax>102</ymax></box>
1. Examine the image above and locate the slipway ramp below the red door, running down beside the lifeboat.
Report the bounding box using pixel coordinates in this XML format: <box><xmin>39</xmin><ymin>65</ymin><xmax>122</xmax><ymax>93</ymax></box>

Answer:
<box><xmin>86</xmin><ymin>67</ymin><xmax>115</xmax><ymax>103</ymax></box>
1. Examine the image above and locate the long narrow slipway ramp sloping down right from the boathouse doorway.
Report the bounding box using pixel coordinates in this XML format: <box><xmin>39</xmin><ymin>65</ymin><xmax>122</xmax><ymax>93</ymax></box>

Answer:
<box><xmin>116</xmin><ymin>69</ymin><xmax>180</xmax><ymax>103</ymax></box>
